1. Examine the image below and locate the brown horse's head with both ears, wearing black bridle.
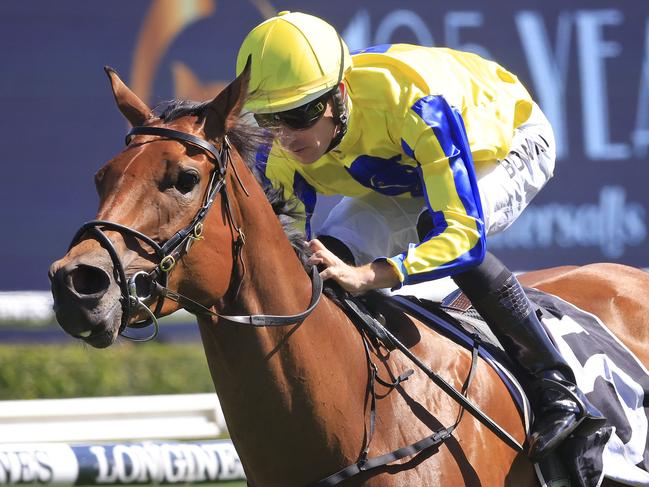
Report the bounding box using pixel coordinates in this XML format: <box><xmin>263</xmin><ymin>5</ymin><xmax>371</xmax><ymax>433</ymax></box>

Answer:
<box><xmin>49</xmin><ymin>63</ymin><xmax>252</xmax><ymax>348</ymax></box>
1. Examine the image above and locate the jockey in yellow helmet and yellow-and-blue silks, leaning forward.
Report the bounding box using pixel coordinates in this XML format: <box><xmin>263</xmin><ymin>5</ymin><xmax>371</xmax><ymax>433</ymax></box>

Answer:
<box><xmin>237</xmin><ymin>12</ymin><xmax>604</xmax><ymax>461</ymax></box>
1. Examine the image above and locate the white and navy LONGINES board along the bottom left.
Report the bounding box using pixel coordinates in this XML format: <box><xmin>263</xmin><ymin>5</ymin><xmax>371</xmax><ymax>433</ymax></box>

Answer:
<box><xmin>0</xmin><ymin>440</ymin><xmax>246</xmax><ymax>485</ymax></box>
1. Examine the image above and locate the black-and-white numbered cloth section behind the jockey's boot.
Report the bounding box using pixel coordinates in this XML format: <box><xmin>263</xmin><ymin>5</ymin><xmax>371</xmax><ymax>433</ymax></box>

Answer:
<box><xmin>528</xmin><ymin>289</ymin><xmax>649</xmax><ymax>486</ymax></box>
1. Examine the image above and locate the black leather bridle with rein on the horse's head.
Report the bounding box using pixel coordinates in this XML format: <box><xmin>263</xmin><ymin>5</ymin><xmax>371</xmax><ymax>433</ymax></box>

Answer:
<box><xmin>70</xmin><ymin>126</ymin><xmax>322</xmax><ymax>341</ymax></box>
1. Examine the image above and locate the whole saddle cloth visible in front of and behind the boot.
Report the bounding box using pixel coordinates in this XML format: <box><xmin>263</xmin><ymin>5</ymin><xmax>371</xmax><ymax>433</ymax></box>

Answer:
<box><xmin>378</xmin><ymin>289</ymin><xmax>649</xmax><ymax>487</ymax></box>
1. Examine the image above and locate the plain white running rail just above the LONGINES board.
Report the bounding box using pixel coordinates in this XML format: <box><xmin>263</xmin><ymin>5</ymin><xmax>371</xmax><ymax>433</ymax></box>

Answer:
<box><xmin>0</xmin><ymin>394</ymin><xmax>226</xmax><ymax>443</ymax></box>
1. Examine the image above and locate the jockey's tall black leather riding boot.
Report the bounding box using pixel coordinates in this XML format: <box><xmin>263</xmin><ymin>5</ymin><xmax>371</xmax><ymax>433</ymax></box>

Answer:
<box><xmin>454</xmin><ymin>253</ymin><xmax>606</xmax><ymax>461</ymax></box>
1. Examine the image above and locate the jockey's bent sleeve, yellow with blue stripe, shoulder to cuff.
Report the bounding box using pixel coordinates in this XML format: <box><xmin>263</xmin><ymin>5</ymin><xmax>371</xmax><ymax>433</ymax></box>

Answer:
<box><xmin>388</xmin><ymin>96</ymin><xmax>485</xmax><ymax>284</ymax></box>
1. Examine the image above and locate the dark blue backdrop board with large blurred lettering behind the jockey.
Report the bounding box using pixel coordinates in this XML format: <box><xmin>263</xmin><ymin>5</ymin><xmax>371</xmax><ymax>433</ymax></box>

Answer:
<box><xmin>0</xmin><ymin>0</ymin><xmax>649</xmax><ymax>290</ymax></box>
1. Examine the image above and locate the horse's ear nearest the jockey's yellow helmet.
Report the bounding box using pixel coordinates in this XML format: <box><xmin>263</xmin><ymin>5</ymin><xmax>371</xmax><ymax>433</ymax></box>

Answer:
<box><xmin>204</xmin><ymin>56</ymin><xmax>250</xmax><ymax>140</ymax></box>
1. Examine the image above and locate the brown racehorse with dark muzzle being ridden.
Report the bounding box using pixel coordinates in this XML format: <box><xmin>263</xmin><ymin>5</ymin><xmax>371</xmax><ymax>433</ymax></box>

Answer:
<box><xmin>50</xmin><ymin>66</ymin><xmax>649</xmax><ymax>487</ymax></box>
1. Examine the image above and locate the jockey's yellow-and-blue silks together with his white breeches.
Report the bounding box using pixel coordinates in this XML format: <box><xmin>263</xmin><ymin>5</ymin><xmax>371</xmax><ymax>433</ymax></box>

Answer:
<box><xmin>253</xmin><ymin>44</ymin><xmax>555</xmax><ymax>284</ymax></box>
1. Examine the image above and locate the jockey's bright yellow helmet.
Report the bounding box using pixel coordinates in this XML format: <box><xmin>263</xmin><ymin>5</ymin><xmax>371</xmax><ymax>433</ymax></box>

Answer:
<box><xmin>237</xmin><ymin>12</ymin><xmax>352</xmax><ymax>113</ymax></box>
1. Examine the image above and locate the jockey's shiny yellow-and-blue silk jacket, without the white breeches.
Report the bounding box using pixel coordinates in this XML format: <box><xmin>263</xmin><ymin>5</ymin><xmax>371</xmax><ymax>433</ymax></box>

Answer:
<box><xmin>258</xmin><ymin>44</ymin><xmax>532</xmax><ymax>284</ymax></box>
